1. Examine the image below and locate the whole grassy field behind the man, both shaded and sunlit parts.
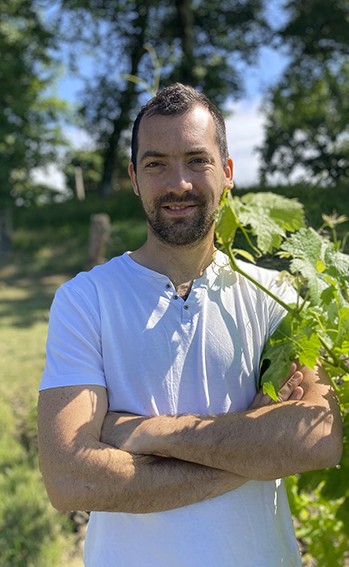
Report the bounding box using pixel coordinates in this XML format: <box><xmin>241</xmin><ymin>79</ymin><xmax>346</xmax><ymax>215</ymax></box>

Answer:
<box><xmin>0</xmin><ymin>187</ymin><xmax>349</xmax><ymax>567</ymax></box>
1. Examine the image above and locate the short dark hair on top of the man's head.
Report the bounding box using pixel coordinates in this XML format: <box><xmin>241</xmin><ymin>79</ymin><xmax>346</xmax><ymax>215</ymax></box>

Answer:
<box><xmin>131</xmin><ymin>83</ymin><xmax>228</xmax><ymax>171</ymax></box>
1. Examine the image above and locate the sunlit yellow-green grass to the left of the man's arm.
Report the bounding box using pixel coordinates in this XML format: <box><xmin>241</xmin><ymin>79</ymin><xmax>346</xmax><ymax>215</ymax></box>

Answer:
<box><xmin>0</xmin><ymin>269</ymin><xmax>83</xmax><ymax>567</ymax></box>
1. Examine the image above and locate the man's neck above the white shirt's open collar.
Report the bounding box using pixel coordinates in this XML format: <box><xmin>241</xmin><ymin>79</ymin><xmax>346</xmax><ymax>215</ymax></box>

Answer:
<box><xmin>131</xmin><ymin>233</ymin><xmax>215</xmax><ymax>290</ymax></box>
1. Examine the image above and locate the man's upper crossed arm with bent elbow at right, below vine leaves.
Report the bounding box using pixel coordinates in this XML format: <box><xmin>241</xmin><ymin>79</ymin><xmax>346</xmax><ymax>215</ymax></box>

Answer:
<box><xmin>102</xmin><ymin>366</ymin><xmax>341</xmax><ymax>480</ymax></box>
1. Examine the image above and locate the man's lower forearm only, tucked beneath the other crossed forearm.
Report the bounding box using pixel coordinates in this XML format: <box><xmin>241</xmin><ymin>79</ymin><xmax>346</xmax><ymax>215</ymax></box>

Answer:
<box><xmin>42</xmin><ymin>447</ymin><xmax>246</xmax><ymax>514</ymax></box>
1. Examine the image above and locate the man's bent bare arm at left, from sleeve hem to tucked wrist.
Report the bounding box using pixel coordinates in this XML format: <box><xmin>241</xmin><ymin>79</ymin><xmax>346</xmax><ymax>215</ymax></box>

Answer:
<box><xmin>38</xmin><ymin>386</ymin><xmax>246</xmax><ymax>514</ymax></box>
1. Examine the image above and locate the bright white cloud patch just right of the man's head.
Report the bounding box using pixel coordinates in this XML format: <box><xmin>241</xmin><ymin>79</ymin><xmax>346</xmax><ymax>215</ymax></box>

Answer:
<box><xmin>226</xmin><ymin>98</ymin><xmax>265</xmax><ymax>187</ymax></box>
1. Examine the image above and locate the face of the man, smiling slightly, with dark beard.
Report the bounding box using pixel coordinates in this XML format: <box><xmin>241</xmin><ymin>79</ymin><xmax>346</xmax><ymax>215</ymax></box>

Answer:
<box><xmin>129</xmin><ymin>105</ymin><xmax>232</xmax><ymax>246</ymax></box>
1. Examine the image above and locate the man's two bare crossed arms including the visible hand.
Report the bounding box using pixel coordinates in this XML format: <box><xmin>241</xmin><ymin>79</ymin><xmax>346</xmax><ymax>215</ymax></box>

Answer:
<box><xmin>38</xmin><ymin>368</ymin><xmax>342</xmax><ymax>513</ymax></box>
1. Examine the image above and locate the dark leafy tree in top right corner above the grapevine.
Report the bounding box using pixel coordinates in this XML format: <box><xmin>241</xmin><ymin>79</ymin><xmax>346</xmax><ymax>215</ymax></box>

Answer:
<box><xmin>261</xmin><ymin>0</ymin><xmax>349</xmax><ymax>184</ymax></box>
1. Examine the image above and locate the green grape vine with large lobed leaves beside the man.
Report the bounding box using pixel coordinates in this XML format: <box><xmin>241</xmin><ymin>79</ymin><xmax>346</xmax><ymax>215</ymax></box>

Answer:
<box><xmin>216</xmin><ymin>191</ymin><xmax>349</xmax><ymax>566</ymax></box>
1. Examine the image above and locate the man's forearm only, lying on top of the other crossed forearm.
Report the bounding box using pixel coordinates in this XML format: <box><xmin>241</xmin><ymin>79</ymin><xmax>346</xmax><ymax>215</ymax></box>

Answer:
<box><xmin>124</xmin><ymin>403</ymin><xmax>336</xmax><ymax>480</ymax></box>
